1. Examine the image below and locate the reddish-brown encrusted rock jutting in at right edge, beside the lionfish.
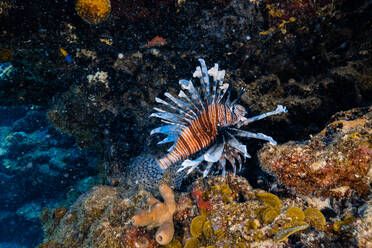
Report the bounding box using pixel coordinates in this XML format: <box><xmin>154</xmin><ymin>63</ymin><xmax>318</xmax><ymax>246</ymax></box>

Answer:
<box><xmin>259</xmin><ymin>108</ymin><xmax>372</xmax><ymax>198</ymax></box>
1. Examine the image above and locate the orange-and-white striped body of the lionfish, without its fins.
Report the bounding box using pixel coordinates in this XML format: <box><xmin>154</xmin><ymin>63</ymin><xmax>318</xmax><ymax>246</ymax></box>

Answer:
<box><xmin>159</xmin><ymin>103</ymin><xmax>234</xmax><ymax>170</ymax></box>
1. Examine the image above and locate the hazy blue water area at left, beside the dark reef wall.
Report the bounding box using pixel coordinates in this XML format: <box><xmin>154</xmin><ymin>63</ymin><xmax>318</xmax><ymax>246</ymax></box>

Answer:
<box><xmin>0</xmin><ymin>106</ymin><xmax>100</xmax><ymax>248</ymax></box>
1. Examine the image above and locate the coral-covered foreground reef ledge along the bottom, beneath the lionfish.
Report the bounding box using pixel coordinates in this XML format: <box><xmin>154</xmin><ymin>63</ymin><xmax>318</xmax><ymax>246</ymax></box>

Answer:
<box><xmin>40</xmin><ymin>170</ymin><xmax>370</xmax><ymax>248</ymax></box>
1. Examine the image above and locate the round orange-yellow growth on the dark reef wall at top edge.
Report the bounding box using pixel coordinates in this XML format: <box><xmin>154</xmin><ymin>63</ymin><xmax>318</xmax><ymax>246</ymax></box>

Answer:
<box><xmin>75</xmin><ymin>0</ymin><xmax>111</xmax><ymax>24</ymax></box>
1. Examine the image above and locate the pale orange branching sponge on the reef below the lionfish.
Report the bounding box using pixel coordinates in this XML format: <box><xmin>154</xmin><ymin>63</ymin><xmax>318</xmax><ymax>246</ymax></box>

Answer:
<box><xmin>133</xmin><ymin>184</ymin><xmax>176</xmax><ymax>245</ymax></box>
